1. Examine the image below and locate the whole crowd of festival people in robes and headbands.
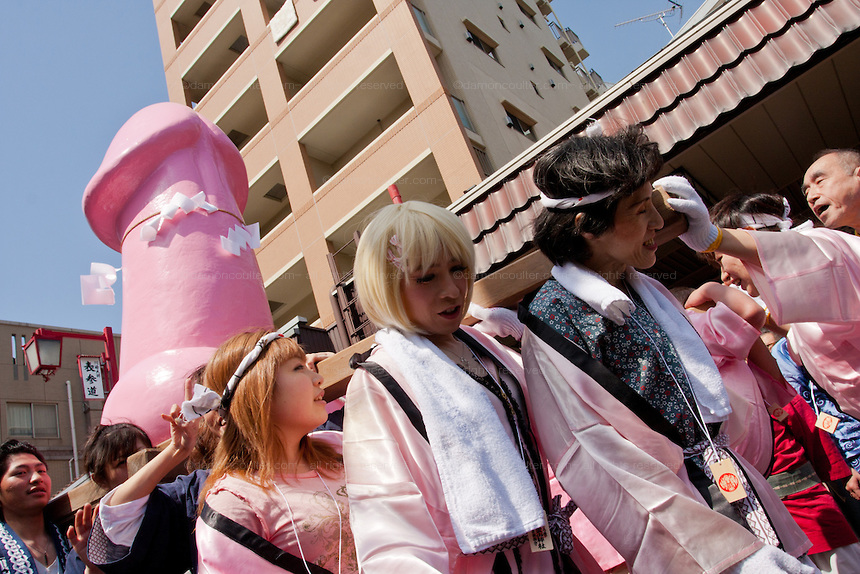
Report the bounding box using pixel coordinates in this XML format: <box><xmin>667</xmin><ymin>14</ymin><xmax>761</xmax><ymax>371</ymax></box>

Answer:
<box><xmin>6</xmin><ymin>126</ymin><xmax>860</xmax><ymax>574</ymax></box>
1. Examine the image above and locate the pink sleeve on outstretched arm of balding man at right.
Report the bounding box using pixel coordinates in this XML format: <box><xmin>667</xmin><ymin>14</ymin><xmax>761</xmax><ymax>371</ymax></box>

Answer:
<box><xmin>747</xmin><ymin>229</ymin><xmax>860</xmax><ymax>324</ymax></box>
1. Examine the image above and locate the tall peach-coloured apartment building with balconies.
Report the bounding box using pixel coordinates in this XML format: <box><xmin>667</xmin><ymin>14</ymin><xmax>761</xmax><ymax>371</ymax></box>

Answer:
<box><xmin>149</xmin><ymin>0</ymin><xmax>605</xmax><ymax>349</ymax></box>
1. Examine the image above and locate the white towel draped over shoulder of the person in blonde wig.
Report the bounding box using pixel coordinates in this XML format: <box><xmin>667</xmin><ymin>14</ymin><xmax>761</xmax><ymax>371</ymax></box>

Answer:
<box><xmin>376</xmin><ymin>329</ymin><xmax>546</xmax><ymax>554</ymax></box>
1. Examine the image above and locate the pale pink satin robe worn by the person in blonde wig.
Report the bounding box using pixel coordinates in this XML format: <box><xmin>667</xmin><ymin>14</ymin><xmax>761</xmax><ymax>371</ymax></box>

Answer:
<box><xmin>343</xmin><ymin>327</ymin><xmax>600</xmax><ymax>574</ymax></box>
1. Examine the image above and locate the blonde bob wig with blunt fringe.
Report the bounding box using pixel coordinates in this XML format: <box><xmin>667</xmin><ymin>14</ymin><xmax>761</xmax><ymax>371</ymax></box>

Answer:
<box><xmin>354</xmin><ymin>201</ymin><xmax>475</xmax><ymax>333</ymax></box>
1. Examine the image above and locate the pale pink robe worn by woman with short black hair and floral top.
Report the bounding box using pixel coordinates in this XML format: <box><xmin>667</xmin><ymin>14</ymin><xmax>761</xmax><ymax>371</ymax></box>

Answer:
<box><xmin>523</xmin><ymin>277</ymin><xmax>810</xmax><ymax>574</ymax></box>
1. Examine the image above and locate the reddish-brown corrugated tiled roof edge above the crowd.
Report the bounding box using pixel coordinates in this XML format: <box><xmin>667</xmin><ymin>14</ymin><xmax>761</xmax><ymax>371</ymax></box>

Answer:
<box><xmin>452</xmin><ymin>0</ymin><xmax>860</xmax><ymax>276</ymax></box>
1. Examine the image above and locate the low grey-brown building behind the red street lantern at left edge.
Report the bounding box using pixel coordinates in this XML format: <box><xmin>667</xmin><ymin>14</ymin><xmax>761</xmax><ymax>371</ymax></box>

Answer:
<box><xmin>0</xmin><ymin>321</ymin><xmax>119</xmax><ymax>494</ymax></box>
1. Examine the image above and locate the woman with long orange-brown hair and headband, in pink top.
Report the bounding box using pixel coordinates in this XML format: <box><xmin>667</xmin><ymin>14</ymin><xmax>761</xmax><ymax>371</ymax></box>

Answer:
<box><xmin>191</xmin><ymin>332</ymin><xmax>358</xmax><ymax>574</ymax></box>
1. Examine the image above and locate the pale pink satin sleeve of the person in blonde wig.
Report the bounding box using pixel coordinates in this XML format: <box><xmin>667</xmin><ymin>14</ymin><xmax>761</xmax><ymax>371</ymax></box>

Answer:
<box><xmin>343</xmin><ymin>362</ymin><xmax>456</xmax><ymax>574</ymax></box>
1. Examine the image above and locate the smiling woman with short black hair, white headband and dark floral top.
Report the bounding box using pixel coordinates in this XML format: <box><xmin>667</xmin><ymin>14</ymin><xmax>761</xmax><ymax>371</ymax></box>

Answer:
<box><xmin>522</xmin><ymin>126</ymin><xmax>814</xmax><ymax>574</ymax></box>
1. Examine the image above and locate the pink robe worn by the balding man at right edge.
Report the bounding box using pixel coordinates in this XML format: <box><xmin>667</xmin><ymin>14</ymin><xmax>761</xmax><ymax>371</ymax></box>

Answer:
<box><xmin>746</xmin><ymin>229</ymin><xmax>860</xmax><ymax>417</ymax></box>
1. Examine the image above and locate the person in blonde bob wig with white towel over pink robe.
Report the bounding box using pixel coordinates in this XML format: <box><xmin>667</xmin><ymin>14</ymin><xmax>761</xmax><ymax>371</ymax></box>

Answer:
<box><xmin>344</xmin><ymin>201</ymin><xmax>596</xmax><ymax>574</ymax></box>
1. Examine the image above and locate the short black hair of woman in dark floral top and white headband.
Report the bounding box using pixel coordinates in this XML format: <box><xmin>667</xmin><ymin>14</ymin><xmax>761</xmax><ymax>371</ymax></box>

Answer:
<box><xmin>533</xmin><ymin>124</ymin><xmax>663</xmax><ymax>265</ymax></box>
